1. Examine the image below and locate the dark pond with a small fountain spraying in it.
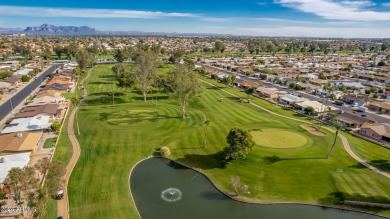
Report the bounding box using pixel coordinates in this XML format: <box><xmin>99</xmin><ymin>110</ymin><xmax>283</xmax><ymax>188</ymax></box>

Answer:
<box><xmin>130</xmin><ymin>158</ymin><xmax>382</xmax><ymax>219</ymax></box>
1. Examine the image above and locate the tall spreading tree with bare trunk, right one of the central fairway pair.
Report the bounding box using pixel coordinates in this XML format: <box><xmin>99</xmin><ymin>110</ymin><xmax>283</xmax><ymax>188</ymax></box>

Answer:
<box><xmin>168</xmin><ymin>65</ymin><xmax>201</xmax><ymax>119</ymax></box>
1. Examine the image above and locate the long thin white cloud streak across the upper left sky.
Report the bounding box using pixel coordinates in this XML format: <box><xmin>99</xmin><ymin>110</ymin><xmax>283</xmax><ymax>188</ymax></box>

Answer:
<box><xmin>0</xmin><ymin>5</ymin><xmax>198</xmax><ymax>19</ymax></box>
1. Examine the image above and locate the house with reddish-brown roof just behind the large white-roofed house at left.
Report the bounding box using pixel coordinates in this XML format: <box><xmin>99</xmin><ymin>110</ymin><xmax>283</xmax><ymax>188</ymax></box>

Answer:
<box><xmin>15</xmin><ymin>103</ymin><xmax>61</xmax><ymax>119</ymax></box>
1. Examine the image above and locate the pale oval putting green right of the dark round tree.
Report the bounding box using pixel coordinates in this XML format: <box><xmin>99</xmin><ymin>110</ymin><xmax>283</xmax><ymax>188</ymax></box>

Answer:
<box><xmin>251</xmin><ymin>129</ymin><xmax>307</xmax><ymax>148</ymax></box>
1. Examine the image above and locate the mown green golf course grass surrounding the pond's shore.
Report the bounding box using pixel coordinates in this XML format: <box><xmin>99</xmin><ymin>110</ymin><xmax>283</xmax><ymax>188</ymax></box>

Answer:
<box><xmin>68</xmin><ymin>65</ymin><xmax>390</xmax><ymax>219</ymax></box>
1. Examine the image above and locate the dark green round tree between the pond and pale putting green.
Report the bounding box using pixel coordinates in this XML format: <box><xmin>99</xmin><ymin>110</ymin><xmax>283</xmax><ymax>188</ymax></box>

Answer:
<box><xmin>225</xmin><ymin>127</ymin><xmax>255</xmax><ymax>160</ymax></box>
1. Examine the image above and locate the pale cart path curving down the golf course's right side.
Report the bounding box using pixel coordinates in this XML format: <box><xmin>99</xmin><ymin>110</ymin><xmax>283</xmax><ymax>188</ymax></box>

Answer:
<box><xmin>199</xmin><ymin>79</ymin><xmax>390</xmax><ymax>179</ymax></box>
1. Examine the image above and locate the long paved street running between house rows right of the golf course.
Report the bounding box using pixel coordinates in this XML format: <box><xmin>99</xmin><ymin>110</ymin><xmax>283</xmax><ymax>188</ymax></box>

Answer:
<box><xmin>200</xmin><ymin>63</ymin><xmax>390</xmax><ymax>123</ymax></box>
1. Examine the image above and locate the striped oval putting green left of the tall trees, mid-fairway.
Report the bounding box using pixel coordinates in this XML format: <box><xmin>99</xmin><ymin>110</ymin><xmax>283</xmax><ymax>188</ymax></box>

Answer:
<box><xmin>107</xmin><ymin>110</ymin><xmax>158</xmax><ymax>125</ymax></box>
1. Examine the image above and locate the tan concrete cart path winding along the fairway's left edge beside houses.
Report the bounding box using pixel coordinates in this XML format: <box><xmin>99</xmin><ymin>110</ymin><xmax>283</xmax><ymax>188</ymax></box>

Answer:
<box><xmin>57</xmin><ymin>69</ymin><xmax>92</xmax><ymax>219</ymax></box>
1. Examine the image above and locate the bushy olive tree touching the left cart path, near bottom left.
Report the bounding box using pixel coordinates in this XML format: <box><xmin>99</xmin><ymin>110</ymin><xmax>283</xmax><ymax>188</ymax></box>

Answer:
<box><xmin>45</xmin><ymin>160</ymin><xmax>66</xmax><ymax>196</ymax></box>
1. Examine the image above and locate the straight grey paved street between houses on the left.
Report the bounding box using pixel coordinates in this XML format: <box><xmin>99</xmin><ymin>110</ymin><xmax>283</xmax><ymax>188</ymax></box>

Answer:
<box><xmin>0</xmin><ymin>64</ymin><xmax>59</xmax><ymax>121</ymax></box>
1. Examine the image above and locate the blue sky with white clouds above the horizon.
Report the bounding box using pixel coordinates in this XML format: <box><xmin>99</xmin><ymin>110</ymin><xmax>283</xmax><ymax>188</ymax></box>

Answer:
<box><xmin>0</xmin><ymin>0</ymin><xmax>390</xmax><ymax>38</ymax></box>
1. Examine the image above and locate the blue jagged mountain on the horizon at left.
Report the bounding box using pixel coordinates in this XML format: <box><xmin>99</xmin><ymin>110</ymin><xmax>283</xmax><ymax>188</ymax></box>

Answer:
<box><xmin>23</xmin><ymin>24</ymin><xmax>96</xmax><ymax>35</ymax></box>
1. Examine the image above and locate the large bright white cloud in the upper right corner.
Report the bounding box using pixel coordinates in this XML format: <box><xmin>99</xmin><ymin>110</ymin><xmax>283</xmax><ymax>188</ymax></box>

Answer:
<box><xmin>274</xmin><ymin>0</ymin><xmax>390</xmax><ymax>21</ymax></box>
